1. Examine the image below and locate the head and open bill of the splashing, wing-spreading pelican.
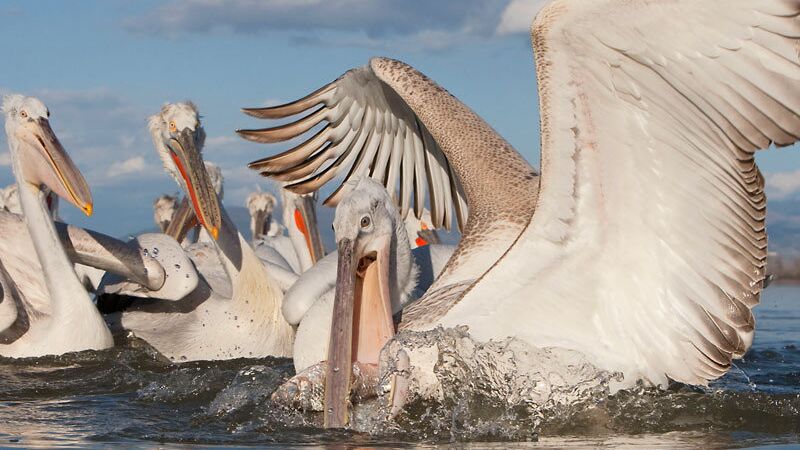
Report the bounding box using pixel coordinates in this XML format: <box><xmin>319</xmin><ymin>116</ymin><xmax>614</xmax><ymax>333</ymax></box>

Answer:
<box><xmin>325</xmin><ymin>177</ymin><xmax>408</xmax><ymax>426</ymax></box>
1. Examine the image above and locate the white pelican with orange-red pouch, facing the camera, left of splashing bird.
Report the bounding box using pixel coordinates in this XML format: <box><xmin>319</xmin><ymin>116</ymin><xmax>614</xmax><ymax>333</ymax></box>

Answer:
<box><xmin>104</xmin><ymin>103</ymin><xmax>294</xmax><ymax>362</ymax></box>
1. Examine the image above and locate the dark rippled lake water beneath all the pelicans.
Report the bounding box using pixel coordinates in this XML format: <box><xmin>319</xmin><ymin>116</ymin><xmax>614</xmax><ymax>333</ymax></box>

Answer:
<box><xmin>0</xmin><ymin>285</ymin><xmax>800</xmax><ymax>448</ymax></box>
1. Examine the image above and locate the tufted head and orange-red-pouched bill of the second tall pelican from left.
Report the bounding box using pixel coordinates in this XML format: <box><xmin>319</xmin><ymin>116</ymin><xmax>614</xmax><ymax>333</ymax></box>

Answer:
<box><xmin>148</xmin><ymin>102</ymin><xmax>222</xmax><ymax>239</ymax></box>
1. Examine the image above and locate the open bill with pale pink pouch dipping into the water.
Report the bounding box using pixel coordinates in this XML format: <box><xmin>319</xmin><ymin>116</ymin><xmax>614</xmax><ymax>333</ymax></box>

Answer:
<box><xmin>324</xmin><ymin>234</ymin><xmax>395</xmax><ymax>428</ymax></box>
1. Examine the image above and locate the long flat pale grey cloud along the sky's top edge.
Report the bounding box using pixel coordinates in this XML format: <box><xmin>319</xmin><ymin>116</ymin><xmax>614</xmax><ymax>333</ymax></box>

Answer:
<box><xmin>124</xmin><ymin>0</ymin><xmax>508</xmax><ymax>49</ymax></box>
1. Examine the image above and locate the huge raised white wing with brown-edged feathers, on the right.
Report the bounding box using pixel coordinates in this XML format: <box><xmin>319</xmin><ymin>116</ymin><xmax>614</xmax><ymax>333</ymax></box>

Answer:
<box><xmin>450</xmin><ymin>0</ymin><xmax>800</xmax><ymax>384</ymax></box>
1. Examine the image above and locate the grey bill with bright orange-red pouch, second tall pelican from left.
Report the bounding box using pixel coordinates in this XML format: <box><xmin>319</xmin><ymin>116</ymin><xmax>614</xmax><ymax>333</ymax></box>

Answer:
<box><xmin>167</xmin><ymin>129</ymin><xmax>222</xmax><ymax>239</ymax></box>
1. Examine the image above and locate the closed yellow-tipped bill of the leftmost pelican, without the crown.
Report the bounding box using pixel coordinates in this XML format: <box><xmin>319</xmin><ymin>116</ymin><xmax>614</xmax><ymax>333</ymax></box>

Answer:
<box><xmin>19</xmin><ymin>118</ymin><xmax>93</xmax><ymax>216</ymax></box>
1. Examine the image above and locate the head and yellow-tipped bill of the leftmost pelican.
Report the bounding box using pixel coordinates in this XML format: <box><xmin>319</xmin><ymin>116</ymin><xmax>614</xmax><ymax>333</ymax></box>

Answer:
<box><xmin>3</xmin><ymin>95</ymin><xmax>93</xmax><ymax>216</ymax></box>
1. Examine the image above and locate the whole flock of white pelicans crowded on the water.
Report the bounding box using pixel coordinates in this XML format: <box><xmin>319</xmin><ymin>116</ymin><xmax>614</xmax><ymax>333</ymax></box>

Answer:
<box><xmin>0</xmin><ymin>0</ymin><xmax>800</xmax><ymax>427</ymax></box>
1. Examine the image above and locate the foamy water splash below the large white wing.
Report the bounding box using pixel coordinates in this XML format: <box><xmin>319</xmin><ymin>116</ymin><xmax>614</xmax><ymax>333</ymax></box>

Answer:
<box><xmin>344</xmin><ymin>328</ymin><xmax>617</xmax><ymax>441</ymax></box>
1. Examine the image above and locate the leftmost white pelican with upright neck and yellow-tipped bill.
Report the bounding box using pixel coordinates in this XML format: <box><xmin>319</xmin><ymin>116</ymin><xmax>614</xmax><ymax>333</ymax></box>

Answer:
<box><xmin>0</xmin><ymin>95</ymin><xmax>114</xmax><ymax>357</ymax></box>
